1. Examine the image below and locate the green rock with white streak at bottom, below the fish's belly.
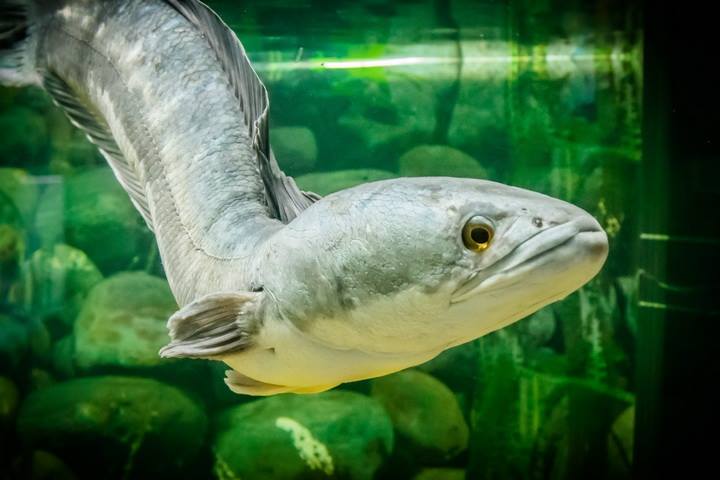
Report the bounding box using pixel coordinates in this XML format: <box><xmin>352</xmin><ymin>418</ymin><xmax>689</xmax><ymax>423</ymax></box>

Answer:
<box><xmin>213</xmin><ymin>391</ymin><xmax>393</xmax><ymax>480</ymax></box>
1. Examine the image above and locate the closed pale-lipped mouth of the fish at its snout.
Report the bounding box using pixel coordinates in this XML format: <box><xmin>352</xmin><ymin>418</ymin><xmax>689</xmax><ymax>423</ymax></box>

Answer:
<box><xmin>450</xmin><ymin>216</ymin><xmax>608</xmax><ymax>304</ymax></box>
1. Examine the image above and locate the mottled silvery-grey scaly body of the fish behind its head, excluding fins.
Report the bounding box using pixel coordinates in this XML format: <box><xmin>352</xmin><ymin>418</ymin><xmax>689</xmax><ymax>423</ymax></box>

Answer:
<box><xmin>37</xmin><ymin>0</ymin><xmax>282</xmax><ymax>305</ymax></box>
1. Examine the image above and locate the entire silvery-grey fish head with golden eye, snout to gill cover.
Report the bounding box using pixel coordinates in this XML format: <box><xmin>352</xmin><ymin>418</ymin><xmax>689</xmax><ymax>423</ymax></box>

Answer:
<box><xmin>260</xmin><ymin>177</ymin><xmax>608</xmax><ymax>353</ymax></box>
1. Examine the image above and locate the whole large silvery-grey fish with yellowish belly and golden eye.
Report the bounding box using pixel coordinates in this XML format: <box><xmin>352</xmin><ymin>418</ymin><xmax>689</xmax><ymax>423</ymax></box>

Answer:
<box><xmin>0</xmin><ymin>0</ymin><xmax>608</xmax><ymax>396</ymax></box>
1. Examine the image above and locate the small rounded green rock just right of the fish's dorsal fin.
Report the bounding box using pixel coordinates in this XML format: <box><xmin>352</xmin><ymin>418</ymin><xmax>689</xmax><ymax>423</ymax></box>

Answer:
<box><xmin>270</xmin><ymin>127</ymin><xmax>318</xmax><ymax>175</ymax></box>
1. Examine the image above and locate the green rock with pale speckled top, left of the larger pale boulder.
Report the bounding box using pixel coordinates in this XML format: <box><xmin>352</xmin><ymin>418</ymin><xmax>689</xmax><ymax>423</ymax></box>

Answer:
<box><xmin>25</xmin><ymin>244</ymin><xmax>103</xmax><ymax>333</ymax></box>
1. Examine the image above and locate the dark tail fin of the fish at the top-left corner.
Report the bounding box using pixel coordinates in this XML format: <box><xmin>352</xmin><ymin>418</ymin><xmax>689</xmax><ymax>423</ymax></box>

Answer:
<box><xmin>0</xmin><ymin>0</ymin><xmax>39</xmax><ymax>86</ymax></box>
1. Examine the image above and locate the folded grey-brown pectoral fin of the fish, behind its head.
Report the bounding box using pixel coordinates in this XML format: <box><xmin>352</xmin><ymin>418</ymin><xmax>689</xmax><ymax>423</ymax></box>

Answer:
<box><xmin>160</xmin><ymin>292</ymin><xmax>262</xmax><ymax>358</ymax></box>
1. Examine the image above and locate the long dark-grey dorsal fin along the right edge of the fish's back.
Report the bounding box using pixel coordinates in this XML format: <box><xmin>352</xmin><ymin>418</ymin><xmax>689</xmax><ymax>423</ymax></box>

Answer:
<box><xmin>165</xmin><ymin>0</ymin><xmax>320</xmax><ymax>223</ymax></box>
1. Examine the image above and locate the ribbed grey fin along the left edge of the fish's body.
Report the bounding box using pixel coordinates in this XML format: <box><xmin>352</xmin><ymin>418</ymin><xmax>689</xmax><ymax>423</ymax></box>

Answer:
<box><xmin>42</xmin><ymin>72</ymin><xmax>153</xmax><ymax>230</ymax></box>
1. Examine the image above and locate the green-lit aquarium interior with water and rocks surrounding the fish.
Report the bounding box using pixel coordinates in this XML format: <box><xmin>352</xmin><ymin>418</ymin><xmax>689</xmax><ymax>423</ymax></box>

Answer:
<box><xmin>0</xmin><ymin>0</ymin><xmax>720</xmax><ymax>480</ymax></box>
